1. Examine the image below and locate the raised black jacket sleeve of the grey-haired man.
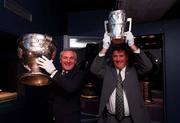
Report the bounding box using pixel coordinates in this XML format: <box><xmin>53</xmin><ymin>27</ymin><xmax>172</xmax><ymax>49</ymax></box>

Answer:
<box><xmin>53</xmin><ymin>70</ymin><xmax>85</xmax><ymax>93</ymax></box>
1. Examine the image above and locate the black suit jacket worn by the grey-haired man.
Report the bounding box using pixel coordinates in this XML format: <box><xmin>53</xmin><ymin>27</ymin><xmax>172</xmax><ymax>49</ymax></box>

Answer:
<box><xmin>50</xmin><ymin>68</ymin><xmax>84</xmax><ymax>123</ymax></box>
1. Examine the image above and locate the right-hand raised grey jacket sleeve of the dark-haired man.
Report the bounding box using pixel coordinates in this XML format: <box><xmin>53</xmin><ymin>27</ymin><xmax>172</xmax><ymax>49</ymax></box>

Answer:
<box><xmin>134</xmin><ymin>50</ymin><xmax>152</xmax><ymax>75</ymax></box>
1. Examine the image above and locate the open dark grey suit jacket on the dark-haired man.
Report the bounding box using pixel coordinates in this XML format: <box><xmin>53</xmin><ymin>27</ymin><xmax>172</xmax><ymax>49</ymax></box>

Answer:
<box><xmin>91</xmin><ymin>51</ymin><xmax>152</xmax><ymax>123</ymax></box>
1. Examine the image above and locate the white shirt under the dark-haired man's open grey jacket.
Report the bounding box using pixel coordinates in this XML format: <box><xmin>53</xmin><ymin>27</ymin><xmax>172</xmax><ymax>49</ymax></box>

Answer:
<box><xmin>106</xmin><ymin>67</ymin><xmax>130</xmax><ymax>116</ymax></box>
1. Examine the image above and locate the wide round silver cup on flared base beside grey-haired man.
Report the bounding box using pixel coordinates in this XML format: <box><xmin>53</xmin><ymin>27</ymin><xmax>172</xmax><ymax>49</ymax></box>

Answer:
<box><xmin>18</xmin><ymin>33</ymin><xmax>56</xmax><ymax>86</ymax></box>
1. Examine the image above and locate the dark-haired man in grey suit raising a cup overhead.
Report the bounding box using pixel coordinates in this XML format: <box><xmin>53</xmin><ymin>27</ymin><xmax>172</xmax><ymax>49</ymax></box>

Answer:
<box><xmin>91</xmin><ymin>32</ymin><xmax>152</xmax><ymax>123</ymax></box>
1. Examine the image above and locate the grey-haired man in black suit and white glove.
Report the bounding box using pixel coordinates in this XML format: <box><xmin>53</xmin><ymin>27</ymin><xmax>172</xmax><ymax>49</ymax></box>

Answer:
<box><xmin>37</xmin><ymin>50</ymin><xmax>84</xmax><ymax>123</ymax></box>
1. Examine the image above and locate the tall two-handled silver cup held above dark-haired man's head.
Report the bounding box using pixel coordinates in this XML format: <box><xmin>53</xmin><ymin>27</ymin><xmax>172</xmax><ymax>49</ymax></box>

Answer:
<box><xmin>104</xmin><ymin>10</ymin><xmax>132</xmax><ymax>43</ymax></box>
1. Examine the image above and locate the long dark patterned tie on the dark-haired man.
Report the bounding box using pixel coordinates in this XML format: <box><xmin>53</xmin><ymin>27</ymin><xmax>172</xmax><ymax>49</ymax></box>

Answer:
<box><xmin>116</xmin><ymin>70</ymin><xmax>124</xmax><ymax>120</ymax></box>
